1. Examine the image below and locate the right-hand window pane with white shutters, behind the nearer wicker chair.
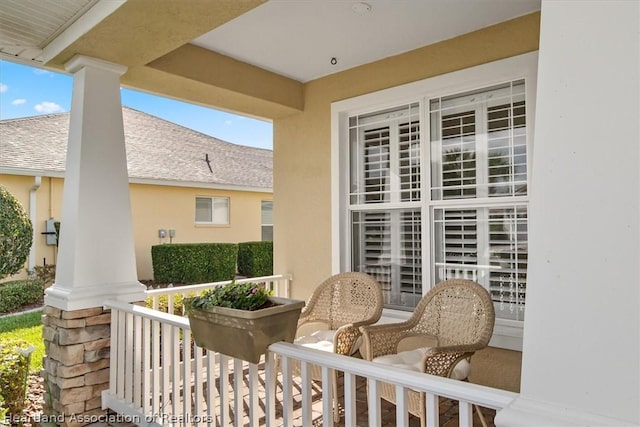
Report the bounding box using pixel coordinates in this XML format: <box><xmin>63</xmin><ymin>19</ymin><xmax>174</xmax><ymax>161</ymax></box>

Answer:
<box><xmin>430</xmin><ymin>80</ymin><xmax>528</xmax><ymax>320</ymax></box>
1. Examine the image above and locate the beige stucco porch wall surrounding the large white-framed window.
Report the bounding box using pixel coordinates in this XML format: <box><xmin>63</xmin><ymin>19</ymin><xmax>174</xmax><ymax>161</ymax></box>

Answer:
<box><xmin>273</xmin><ymin>13</ymin><xmax>540</xmax><ymax>298</ymax></box>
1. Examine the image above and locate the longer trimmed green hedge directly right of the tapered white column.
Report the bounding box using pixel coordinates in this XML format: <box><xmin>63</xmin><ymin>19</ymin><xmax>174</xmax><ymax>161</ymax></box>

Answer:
<box><xmin>151</xmin><ymin>243</ymin><xmax>238</xmax><ymax>284</ymax></box>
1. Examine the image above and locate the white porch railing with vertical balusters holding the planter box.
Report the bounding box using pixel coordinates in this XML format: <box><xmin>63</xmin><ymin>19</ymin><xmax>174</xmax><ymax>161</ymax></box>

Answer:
<box><xmin>102</xmin><ymin>276</ymin><xmax>517</xmax><ymax>427</ymax></box>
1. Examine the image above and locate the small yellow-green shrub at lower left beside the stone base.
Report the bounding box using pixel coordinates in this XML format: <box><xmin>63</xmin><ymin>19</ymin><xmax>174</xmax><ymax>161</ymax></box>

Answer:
<box><xmin>0</xmin><ymin>339</ymin><xmax>33</xmax><ymax>416</ymax></box>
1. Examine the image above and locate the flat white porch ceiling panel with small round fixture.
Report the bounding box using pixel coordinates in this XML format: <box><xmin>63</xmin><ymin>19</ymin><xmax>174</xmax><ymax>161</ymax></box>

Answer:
<box><xmin>192</xmin><ymin>0</ymin><xmax>540</xmax><ymax>82</ymax></box>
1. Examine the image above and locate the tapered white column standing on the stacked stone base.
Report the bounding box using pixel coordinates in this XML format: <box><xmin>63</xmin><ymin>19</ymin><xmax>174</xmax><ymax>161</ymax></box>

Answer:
<box><xmin>45</xmin><ymin>56</ymin><xmax>144</xmax><ymax>310</ymax></box>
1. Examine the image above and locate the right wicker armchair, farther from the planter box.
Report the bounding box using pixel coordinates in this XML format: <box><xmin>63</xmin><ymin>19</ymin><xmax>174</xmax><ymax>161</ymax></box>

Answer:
<box><xmin>360</xmin><ymin>279</ymin><xmax>495</xmax><ymax>427</ymax></box>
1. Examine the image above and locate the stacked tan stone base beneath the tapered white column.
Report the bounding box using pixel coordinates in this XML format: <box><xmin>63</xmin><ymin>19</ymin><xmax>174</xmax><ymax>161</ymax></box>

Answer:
<box><xmin>42</xmin><ymin>306</ymin><xmax>111</xmax><ymax>427</ymax></box>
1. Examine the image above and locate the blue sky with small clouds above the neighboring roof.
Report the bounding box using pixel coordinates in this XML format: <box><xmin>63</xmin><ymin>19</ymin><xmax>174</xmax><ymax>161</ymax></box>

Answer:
<box><xmin>0</xmin><ymin>61</ymin><xmax>273</xmax><ymax>149</ymax></box>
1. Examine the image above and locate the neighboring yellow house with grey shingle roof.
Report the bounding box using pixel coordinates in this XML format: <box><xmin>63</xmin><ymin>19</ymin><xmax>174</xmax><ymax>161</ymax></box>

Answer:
<box><xmin>0</xmin><ymin>107</ymin><xmax>273</xmax><ymax>280</ymax></box>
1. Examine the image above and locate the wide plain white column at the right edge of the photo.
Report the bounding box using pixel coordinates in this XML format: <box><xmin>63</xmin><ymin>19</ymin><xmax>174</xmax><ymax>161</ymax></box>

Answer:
<box><xmin>496</xmin><ymin>0</ymin><xmax>640</xmax><ymax>426</ymax></box>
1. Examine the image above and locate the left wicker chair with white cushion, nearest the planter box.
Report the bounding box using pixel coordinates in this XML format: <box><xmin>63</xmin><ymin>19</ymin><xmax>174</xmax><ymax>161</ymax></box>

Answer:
<box><xmin>294</xmin><ymin>272</ymin><xmax>383</xmax><ymax>421</ymax></box>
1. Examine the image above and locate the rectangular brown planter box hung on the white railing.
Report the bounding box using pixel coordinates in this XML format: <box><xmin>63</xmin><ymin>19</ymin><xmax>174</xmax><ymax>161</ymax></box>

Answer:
<box><xmin>189</xmin><ymin>297</ymin><xmax>304</xmax><ymax>363</ymax></box>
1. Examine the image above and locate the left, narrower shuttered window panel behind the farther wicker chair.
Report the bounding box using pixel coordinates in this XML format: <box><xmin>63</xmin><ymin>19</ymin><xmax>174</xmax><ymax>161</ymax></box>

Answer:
<box><xmin>349</xmin><ymin>104</ymin><xmax>422</xmax><ymax>309</ymax></box>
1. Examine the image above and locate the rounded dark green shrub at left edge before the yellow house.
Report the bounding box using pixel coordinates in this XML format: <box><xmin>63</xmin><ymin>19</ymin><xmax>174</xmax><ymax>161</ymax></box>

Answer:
<box><xmin>0</xmin><ymin>186</ymin><xmax>33</xmax><ymax>279</ymax></box>
